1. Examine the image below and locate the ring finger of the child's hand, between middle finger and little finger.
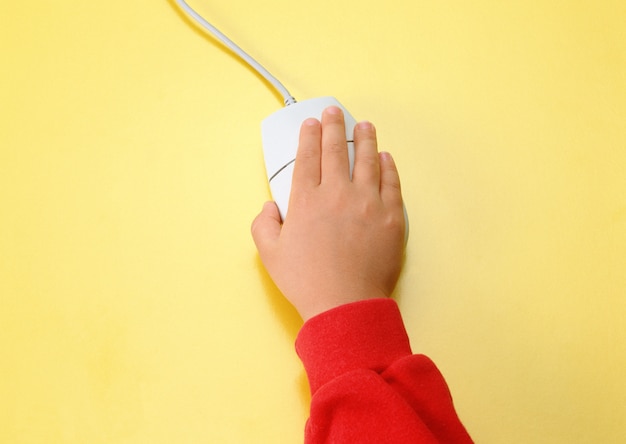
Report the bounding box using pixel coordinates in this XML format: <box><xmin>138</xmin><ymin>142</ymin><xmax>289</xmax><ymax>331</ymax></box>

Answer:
<box><xmin>352</xmin><ymin>122</ymin><xmax>380</xmax><ymax>192</ymax></box>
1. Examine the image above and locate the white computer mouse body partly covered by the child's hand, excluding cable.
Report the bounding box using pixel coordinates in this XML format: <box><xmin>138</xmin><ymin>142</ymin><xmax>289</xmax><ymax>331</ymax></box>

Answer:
<box><xmin>261</xmin><ymin>97</ymin><xmax>409</xmax><ymax>243</ymax></box>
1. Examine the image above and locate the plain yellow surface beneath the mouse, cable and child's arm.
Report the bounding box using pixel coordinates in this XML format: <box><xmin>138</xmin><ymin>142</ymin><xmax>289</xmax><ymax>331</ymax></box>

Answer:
<box><xmin>0</xmin><ymin>0</ymin><xmax>626</xmax><ymax>444</ymax></box>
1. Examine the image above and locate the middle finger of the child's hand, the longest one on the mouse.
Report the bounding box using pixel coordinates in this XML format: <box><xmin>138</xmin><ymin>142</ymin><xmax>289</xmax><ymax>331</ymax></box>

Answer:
<box><xmin>322</xmin><ymin>106</ymin><xmax>350</xmax><ymax>183</ymax></box>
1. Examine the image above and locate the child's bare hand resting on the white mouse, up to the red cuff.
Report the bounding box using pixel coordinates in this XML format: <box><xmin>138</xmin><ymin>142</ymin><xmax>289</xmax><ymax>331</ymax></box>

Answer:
<box><xmin>252</xmin><ymin>107</ymin><xmax>405</xmax><ymax>321</ymax></box>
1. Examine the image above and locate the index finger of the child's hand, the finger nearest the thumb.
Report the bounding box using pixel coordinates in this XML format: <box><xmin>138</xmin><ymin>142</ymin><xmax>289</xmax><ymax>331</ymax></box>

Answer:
<box><xmin>292</xmin><ymin>119</ymin><xmax>322</xmax><ymax>189</ymax></box>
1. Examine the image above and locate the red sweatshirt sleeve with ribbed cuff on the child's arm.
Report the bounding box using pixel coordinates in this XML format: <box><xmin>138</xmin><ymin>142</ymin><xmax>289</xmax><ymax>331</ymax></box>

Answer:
<box><xmin>296</xmin><ymin>299</ymin><xmax>472</xmax><ymax>444</ymax></box>
